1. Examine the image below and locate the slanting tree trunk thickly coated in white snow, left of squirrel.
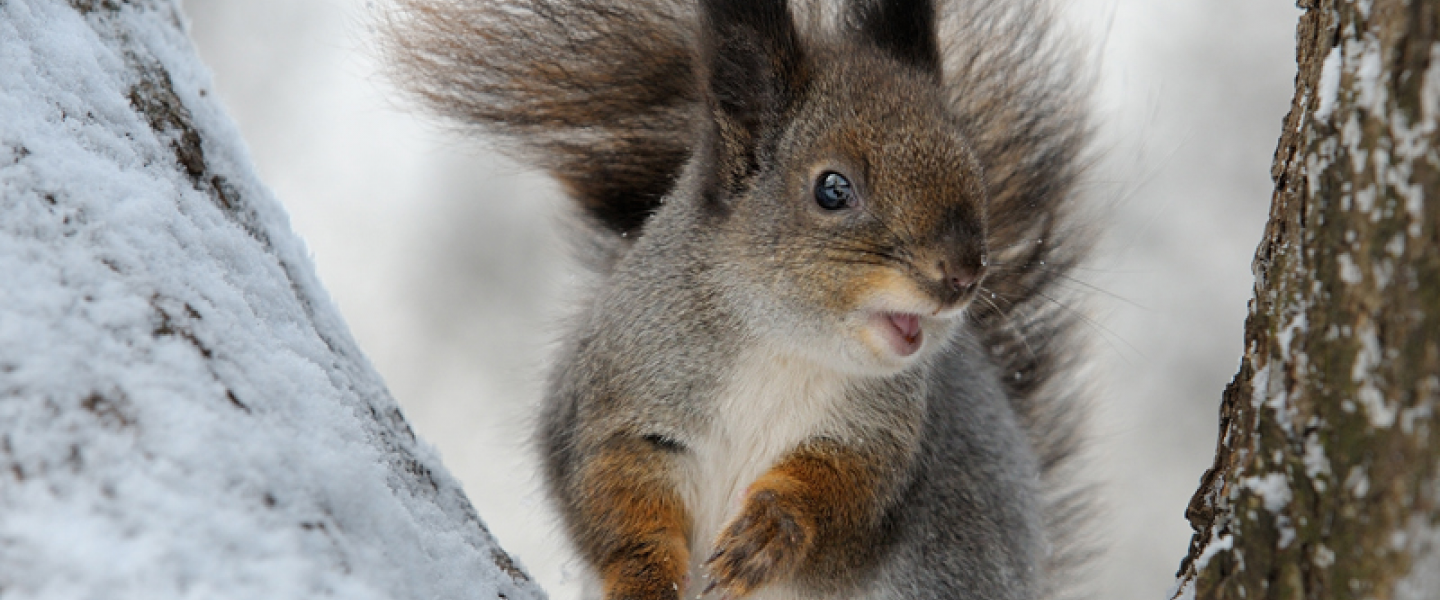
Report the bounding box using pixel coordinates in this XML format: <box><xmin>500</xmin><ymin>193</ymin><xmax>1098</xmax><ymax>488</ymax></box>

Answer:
<box><xmin>0</xmin><ymin>0</ymin><xmax>543</xmax><ymax>600</ymax></box>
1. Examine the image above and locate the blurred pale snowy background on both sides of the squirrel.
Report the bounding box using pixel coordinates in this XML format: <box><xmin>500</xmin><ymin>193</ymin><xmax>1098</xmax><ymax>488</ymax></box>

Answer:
<box><xmin>184</xmin><ymin>0</ymin><xmax>1299</xmax><ymax>592</ymax></box>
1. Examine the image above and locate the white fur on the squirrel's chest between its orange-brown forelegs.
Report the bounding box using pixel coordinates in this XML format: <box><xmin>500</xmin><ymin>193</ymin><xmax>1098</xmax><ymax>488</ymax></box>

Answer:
<box><xmin>681</xmin><ymin>345</ymin><xmax>845</xmax><ymax>599</ymax></box>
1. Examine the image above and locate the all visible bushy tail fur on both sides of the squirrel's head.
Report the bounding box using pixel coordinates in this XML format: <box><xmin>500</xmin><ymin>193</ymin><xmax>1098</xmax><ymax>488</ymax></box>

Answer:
<box><xmin>382</xmin><ymin>0</ymin><xmax>1089</xmax><ymax>591</ymax></box>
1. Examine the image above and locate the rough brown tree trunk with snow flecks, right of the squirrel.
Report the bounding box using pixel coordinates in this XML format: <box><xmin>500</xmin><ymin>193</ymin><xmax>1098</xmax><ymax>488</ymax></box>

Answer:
<box><xmin>1178</xmin><ymin>0</ymin><xmax>1440</xmax><ymax>592</ymax></box>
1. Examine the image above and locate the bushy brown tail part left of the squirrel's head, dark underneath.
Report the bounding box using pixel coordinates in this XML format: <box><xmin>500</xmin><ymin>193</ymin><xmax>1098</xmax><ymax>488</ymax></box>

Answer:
<box><xmin>380</xmin><ymin>0</ymin><xmax>700</xmax><ymax>233</ymax></box>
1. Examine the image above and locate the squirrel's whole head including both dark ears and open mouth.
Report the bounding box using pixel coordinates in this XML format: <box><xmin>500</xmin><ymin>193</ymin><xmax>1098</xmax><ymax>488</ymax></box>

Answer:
<box><xmin>693</xmin><ymin>0</ymin><xmax>988</xmax><ymax>374</ymax></box>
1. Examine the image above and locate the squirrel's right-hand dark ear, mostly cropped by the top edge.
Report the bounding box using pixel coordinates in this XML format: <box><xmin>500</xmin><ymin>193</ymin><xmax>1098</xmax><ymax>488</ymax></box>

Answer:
<box><xmin>851</xmin><ymin>0</ymin><xmax>942</xmax><ymax>75</ymax></box>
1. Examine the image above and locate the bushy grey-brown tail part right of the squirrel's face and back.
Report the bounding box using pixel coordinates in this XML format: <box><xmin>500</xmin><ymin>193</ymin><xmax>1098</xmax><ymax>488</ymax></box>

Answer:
<box><xmin>940</xmin><ymin>0</ymin><xmax>1092</xmax><ymax>599</ymax></box>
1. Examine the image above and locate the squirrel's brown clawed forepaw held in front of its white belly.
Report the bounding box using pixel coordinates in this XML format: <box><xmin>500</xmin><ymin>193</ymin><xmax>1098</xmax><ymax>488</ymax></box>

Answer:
<box><xmin>704</xmin><ymin>489</ymin><xmax>815</xmax><ymax>597</ymax></box>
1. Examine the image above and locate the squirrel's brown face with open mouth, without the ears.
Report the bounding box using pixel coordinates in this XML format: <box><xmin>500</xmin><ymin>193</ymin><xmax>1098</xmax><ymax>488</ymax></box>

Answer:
<box><xmin>699</xmin><ymin>49</ymin><xmax>986</xmax><ymax>374</ymax></box>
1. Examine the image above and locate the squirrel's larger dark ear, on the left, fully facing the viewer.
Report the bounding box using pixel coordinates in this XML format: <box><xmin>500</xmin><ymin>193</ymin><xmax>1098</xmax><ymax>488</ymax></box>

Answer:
<box><xmin>701</xmin><ymin>0</ymin><xmax>805</xmax><ymax>188</ymax></box>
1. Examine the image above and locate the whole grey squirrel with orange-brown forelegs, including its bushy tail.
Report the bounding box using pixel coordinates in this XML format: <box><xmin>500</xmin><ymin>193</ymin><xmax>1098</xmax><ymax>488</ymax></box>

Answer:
<box><xmin>384</xmin><ymin>0</ymin><xmax>1089</xmax><ymax>600</ymax></box>
